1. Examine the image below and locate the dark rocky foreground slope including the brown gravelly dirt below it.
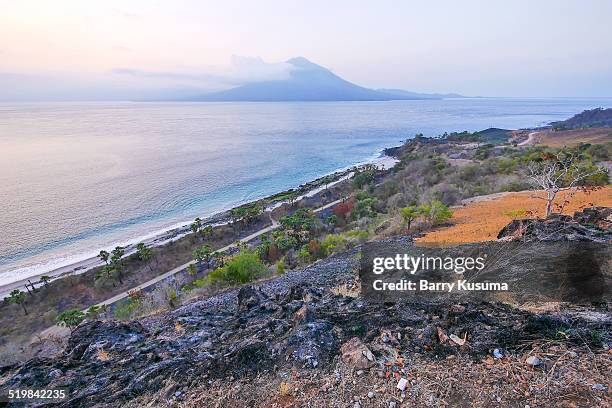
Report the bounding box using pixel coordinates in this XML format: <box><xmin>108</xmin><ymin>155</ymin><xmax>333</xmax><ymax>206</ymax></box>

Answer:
<box><xmin>3</xmin><ymin>239</ymin><xmax>612</xmax><ymax>407</ymax></box>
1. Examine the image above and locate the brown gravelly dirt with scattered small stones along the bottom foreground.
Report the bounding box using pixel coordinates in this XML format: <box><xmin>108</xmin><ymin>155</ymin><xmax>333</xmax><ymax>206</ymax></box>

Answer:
<box><xmin>129</xmin><ymin>342</ymin><xmax>612</xmax><ymax>408</ymax></box>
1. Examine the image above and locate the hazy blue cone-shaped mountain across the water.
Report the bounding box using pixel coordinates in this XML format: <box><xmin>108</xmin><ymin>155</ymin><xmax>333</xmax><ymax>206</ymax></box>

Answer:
<box><xmin>182</xmin><ymin>57</ymin><xmax>462</xmax><ymax>102</ymax></box>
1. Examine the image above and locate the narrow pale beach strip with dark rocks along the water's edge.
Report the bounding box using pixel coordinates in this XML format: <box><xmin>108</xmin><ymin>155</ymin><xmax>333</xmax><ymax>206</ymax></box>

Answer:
<box><xmin>0</xmin><ymin>148</ymin><xmax>398</xmax><ymax>299</ymax></box>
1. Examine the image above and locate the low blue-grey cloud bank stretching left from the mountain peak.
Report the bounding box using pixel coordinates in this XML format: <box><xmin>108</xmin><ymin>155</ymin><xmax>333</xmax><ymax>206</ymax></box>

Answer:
<box><xmin>0</xmin><ymin>56</ymin><xmax>294</xmax><ymax>101</ymax></box>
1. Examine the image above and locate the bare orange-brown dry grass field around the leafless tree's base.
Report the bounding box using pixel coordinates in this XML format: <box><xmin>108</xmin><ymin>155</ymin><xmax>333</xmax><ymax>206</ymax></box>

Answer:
<box><xmin>416</xmin><ymin>186</ymin><xmax>612</xmax><ymax>245</ymax></box>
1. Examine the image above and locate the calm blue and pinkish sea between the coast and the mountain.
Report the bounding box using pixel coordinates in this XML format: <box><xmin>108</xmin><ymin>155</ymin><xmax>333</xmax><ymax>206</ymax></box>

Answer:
<box><xmin>0</xmin><ymin>98</ymin><xmax>612</xmax><ymax>284</ymax></box>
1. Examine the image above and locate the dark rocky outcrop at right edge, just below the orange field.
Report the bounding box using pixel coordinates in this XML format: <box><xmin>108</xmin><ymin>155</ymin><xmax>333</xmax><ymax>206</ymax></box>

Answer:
<box><xmin>497</xmin><ymin>207</ymin><xmax>612</xmax><ymax>243</ymax></box>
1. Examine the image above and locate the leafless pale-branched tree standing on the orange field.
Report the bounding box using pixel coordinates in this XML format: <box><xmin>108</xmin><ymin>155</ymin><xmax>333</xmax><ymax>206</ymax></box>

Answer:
<box><xmin>527</xmin><ymin>151</ymin><xmax>606</xmax><ymax>217</ymax></box>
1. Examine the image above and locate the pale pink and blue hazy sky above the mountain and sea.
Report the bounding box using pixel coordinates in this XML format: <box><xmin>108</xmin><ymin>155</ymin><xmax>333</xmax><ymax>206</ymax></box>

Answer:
<box><xmin>0</xmin><ymin>0</ymin><xmax>612</xmax><ymax>100</ymax></box>
